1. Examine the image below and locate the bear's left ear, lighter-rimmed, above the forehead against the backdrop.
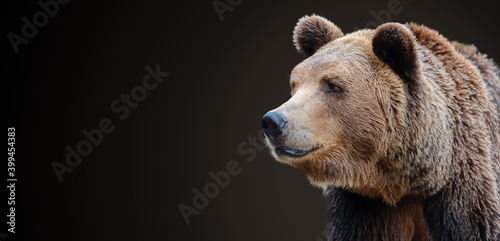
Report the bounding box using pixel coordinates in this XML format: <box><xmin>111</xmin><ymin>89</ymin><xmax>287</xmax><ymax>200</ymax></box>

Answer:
<box><xmin>293</xmin><ymin>15</ymin><xmax>344</xmax><ymax>57</ymax></box>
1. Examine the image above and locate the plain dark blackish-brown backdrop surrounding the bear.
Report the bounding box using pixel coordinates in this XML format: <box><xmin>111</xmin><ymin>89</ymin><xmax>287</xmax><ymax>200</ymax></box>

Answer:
<box><xmin>0</xmin><ymin>0</ymin><xmax>500</xmax><ymax>241</ymax></box>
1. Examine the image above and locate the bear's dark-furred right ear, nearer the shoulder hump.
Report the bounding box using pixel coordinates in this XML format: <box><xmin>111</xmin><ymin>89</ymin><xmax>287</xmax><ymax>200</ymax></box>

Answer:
<box><xmin>372</xmin><ymin>23</ymin><xmax>420</xmax><ymax>89</ymax></box>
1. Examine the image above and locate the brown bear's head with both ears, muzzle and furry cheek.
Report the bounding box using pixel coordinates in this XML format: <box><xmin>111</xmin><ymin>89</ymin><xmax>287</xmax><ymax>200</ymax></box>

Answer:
<box><xmin>262</xmin><ymin>15</ymin><xmax>451</xmax><ymax>204</ymax></box>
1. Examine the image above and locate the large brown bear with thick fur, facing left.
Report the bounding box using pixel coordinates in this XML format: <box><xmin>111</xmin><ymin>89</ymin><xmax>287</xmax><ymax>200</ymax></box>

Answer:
<box><xmin>262</xmin><ymin>15</ymin><xmax>500</xmax><ymax>241</ymax></box>
